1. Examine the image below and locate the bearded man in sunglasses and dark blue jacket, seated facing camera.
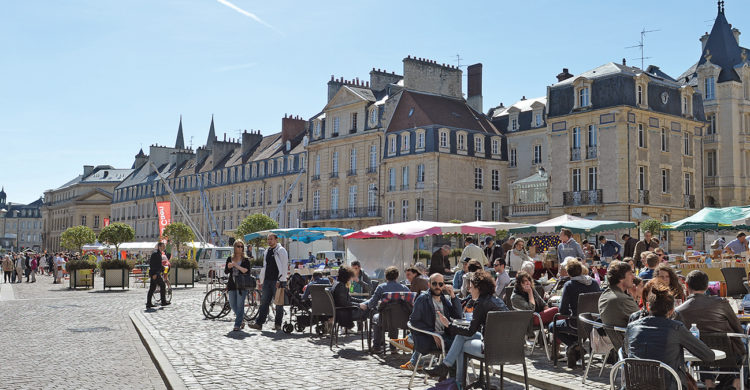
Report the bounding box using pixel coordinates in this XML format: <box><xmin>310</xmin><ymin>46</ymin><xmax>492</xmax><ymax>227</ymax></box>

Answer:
<box><xmin>402</xmin><ymin>273</ymin><xmax>463</xmax><ymax>374</ymax></box>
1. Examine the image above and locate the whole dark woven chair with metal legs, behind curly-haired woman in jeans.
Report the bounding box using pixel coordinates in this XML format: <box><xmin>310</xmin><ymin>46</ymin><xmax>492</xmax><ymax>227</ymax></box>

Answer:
<box><xmin>461</xmin><ymin>310</ymin><xmax>533</xmax><ymax>390</ymax></box>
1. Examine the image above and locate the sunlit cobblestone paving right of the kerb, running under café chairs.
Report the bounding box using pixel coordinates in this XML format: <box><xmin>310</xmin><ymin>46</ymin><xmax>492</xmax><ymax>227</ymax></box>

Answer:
<box><xmin>131</xmin><ymin>287</ymin><xmax>609</xmax><ymax>389</ymax></box>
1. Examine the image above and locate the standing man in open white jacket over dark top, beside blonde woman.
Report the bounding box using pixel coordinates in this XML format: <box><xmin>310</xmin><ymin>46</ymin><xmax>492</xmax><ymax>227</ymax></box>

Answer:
<box><xmin>249</xmin><ymin>233</ymin><xmax>289</xmax><ymax>331</ymax></box>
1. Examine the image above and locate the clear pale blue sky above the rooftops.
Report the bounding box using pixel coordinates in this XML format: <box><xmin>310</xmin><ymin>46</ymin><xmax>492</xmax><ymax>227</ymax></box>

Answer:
<box><xmin>0</xmin><ymin>0</ymin><xmax>750</xmax><ymax>203</ymax></box>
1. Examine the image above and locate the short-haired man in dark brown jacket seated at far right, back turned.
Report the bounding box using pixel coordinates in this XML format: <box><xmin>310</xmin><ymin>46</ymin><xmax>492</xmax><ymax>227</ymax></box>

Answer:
<box><xmin>674</xmin><ymin>270</ymin><xmax>746</xmax><ymax>389</ymax></box>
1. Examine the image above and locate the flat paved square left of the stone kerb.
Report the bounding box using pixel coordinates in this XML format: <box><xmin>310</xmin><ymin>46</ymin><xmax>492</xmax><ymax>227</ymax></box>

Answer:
<box><xmin>0</xmin><ymin>276</ymin><xmax>166</xmax><ymax>389</ymax></box>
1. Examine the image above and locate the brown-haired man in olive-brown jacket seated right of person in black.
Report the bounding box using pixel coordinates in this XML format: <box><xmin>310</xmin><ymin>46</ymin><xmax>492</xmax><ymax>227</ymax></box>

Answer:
<box><xmin>599</xmin><ymin>260</ymin><xmax>639</xmax><ymax>349</ymax></box>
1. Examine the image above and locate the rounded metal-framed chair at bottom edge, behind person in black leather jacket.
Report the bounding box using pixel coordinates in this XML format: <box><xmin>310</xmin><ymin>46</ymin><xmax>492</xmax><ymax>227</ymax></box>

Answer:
<box><xmin>609</xmin><ymin>358</ymin><xmax>682</xmax><ymax>390</ymax></box>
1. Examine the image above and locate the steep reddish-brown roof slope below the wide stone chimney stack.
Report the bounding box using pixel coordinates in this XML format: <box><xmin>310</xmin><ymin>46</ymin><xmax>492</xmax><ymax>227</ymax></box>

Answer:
<box><xmin>386</xmin><ymin>90</ymin><xmax>500</xmax><ymax>134</ymax></box>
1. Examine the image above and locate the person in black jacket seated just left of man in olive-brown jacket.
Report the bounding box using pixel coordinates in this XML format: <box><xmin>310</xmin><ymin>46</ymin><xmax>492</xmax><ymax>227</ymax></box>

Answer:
<box><xmin>549</xmin><ymin>259</ymin><xmax>599</xmax><ymax>368</ymax></box>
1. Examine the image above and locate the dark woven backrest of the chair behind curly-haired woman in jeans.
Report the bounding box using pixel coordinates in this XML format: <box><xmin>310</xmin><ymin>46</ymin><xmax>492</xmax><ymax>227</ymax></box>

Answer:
<box><xmin>484</xmin><ymin>310</ymin><xmax>533</xmax><ymax>365</ymax></box>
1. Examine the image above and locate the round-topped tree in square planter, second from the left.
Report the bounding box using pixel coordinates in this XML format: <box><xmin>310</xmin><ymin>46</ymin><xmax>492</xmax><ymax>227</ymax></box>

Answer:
<box><xmin>99</xmin><ymin>223</ymin><xmax>135</xmax><ymax>289</ymax></box>
